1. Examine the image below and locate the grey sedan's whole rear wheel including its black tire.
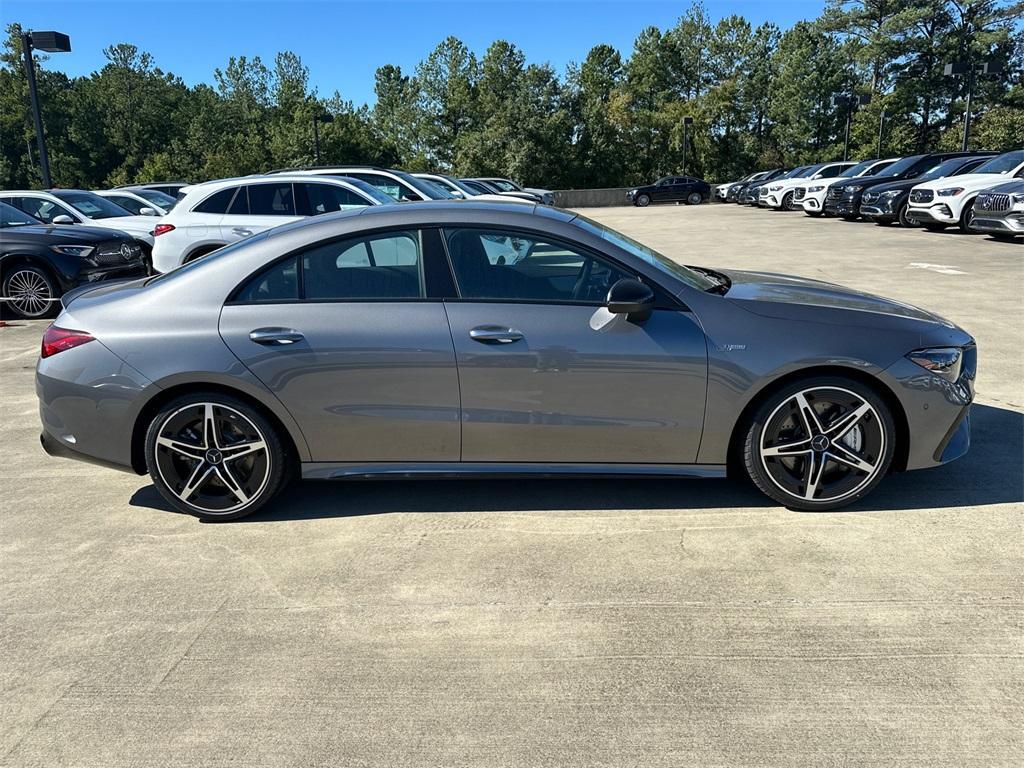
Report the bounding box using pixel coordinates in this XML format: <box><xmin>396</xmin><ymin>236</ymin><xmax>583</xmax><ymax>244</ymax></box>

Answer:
<box><xmin>145</xmin><ymin>392</ymin><xmax>290</xmax><ymax>522</ymax></box>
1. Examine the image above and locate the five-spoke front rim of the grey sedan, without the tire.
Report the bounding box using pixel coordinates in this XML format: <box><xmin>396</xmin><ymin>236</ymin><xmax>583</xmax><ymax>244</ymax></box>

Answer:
<box><xmin>759</xmin><ymin>387</ymin><xmax>887</xmax><ymax>503</ymax></box>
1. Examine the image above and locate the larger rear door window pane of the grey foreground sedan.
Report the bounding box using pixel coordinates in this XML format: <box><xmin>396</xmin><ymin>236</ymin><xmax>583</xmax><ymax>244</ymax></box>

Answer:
<box><xmin>302</xmin><ymin>231</ymin><xmax>424</xmax><ymax>301</ymax></box>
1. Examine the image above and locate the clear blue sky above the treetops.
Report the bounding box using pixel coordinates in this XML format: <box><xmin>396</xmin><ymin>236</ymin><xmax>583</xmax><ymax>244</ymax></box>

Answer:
<box><xmin>0</xmin><ymin>0</ymin><xmax>824</xmax><ymax>104</ymax></box>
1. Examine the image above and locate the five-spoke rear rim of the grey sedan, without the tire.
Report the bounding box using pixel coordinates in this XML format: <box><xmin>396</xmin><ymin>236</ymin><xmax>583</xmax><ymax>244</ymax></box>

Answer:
<box><xmin>155</xmin><ymin>402</ymin><xmax>272</xmax><ymax>515</ymax></box>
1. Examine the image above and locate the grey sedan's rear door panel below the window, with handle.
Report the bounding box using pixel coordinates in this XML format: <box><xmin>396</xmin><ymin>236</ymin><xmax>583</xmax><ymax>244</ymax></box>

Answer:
<box><xmin>220</xmin><ymin>301</ymin><xmax>460</xmax><ymax>462</ymax></box>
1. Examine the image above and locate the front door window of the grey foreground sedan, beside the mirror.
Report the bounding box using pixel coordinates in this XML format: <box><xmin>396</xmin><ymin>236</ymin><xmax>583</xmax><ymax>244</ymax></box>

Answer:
<box><xmin>444</xmin><ymin>229</ymin><xmax>636</xmax><ymax>303</ymax></box>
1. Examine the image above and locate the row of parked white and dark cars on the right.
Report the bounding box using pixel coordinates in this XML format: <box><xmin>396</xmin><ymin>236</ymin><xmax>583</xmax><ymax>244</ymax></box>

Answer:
<box><xmin>715</xmin><ymin>150</ymin><xmax>1024</xmax><ymax>240</ymax></box>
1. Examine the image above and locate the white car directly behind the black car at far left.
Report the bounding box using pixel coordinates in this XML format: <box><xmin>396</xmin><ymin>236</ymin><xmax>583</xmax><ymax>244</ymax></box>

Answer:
<box><xmin>0</xmin><ymin>189</ymin><xmax>157</xmax><ymax>244</ymax></box>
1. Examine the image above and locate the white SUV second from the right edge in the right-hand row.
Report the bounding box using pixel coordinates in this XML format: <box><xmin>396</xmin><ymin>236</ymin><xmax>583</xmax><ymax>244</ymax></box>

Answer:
<box><xmin>906</xmin><ymin>150</ymin><xmax>1024</xmax><ymax>232</ymax></box>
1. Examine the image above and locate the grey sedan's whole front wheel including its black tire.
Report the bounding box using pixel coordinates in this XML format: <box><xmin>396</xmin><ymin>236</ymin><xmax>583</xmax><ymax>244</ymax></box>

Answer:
<box><xmin>742</xmin><ymin>376</ymin><xmax>896</xmax><ymax>511</ymax></box>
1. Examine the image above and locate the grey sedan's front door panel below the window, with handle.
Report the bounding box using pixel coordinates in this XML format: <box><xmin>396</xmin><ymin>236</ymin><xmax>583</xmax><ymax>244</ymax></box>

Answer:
<box><xmin>446</xmin><ymin>302</ymin><xmax>708</xmax><ymax>463</ymax></box>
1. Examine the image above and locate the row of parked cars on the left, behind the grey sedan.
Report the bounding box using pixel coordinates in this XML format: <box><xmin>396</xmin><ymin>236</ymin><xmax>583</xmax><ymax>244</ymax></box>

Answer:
<box><xmin>0</xmin><ymin>171</ymin><xmax>554</xmax><ymax>317</ymax></box>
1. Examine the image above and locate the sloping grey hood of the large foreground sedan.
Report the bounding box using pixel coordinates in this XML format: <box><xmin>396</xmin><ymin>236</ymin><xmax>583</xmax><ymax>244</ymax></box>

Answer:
<box><xmin>725</xmin><ymin>270</ymin><xmax>955</xmax><ymax>328</ymax></box>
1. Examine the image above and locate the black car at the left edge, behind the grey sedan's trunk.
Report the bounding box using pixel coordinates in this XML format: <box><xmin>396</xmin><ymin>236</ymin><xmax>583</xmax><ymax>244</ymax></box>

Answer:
<box><xmin>0</xmin><ymin>203</ymin><xmax>146</xmax><ymax>318</ymax></box>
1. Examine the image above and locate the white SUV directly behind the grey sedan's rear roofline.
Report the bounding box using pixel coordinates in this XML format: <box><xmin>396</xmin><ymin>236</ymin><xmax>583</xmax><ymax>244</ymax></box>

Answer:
<box><xmin>153</xmin><ymin>173</ymin><xmax>393</xmax><ymax>272</ymax></box>
